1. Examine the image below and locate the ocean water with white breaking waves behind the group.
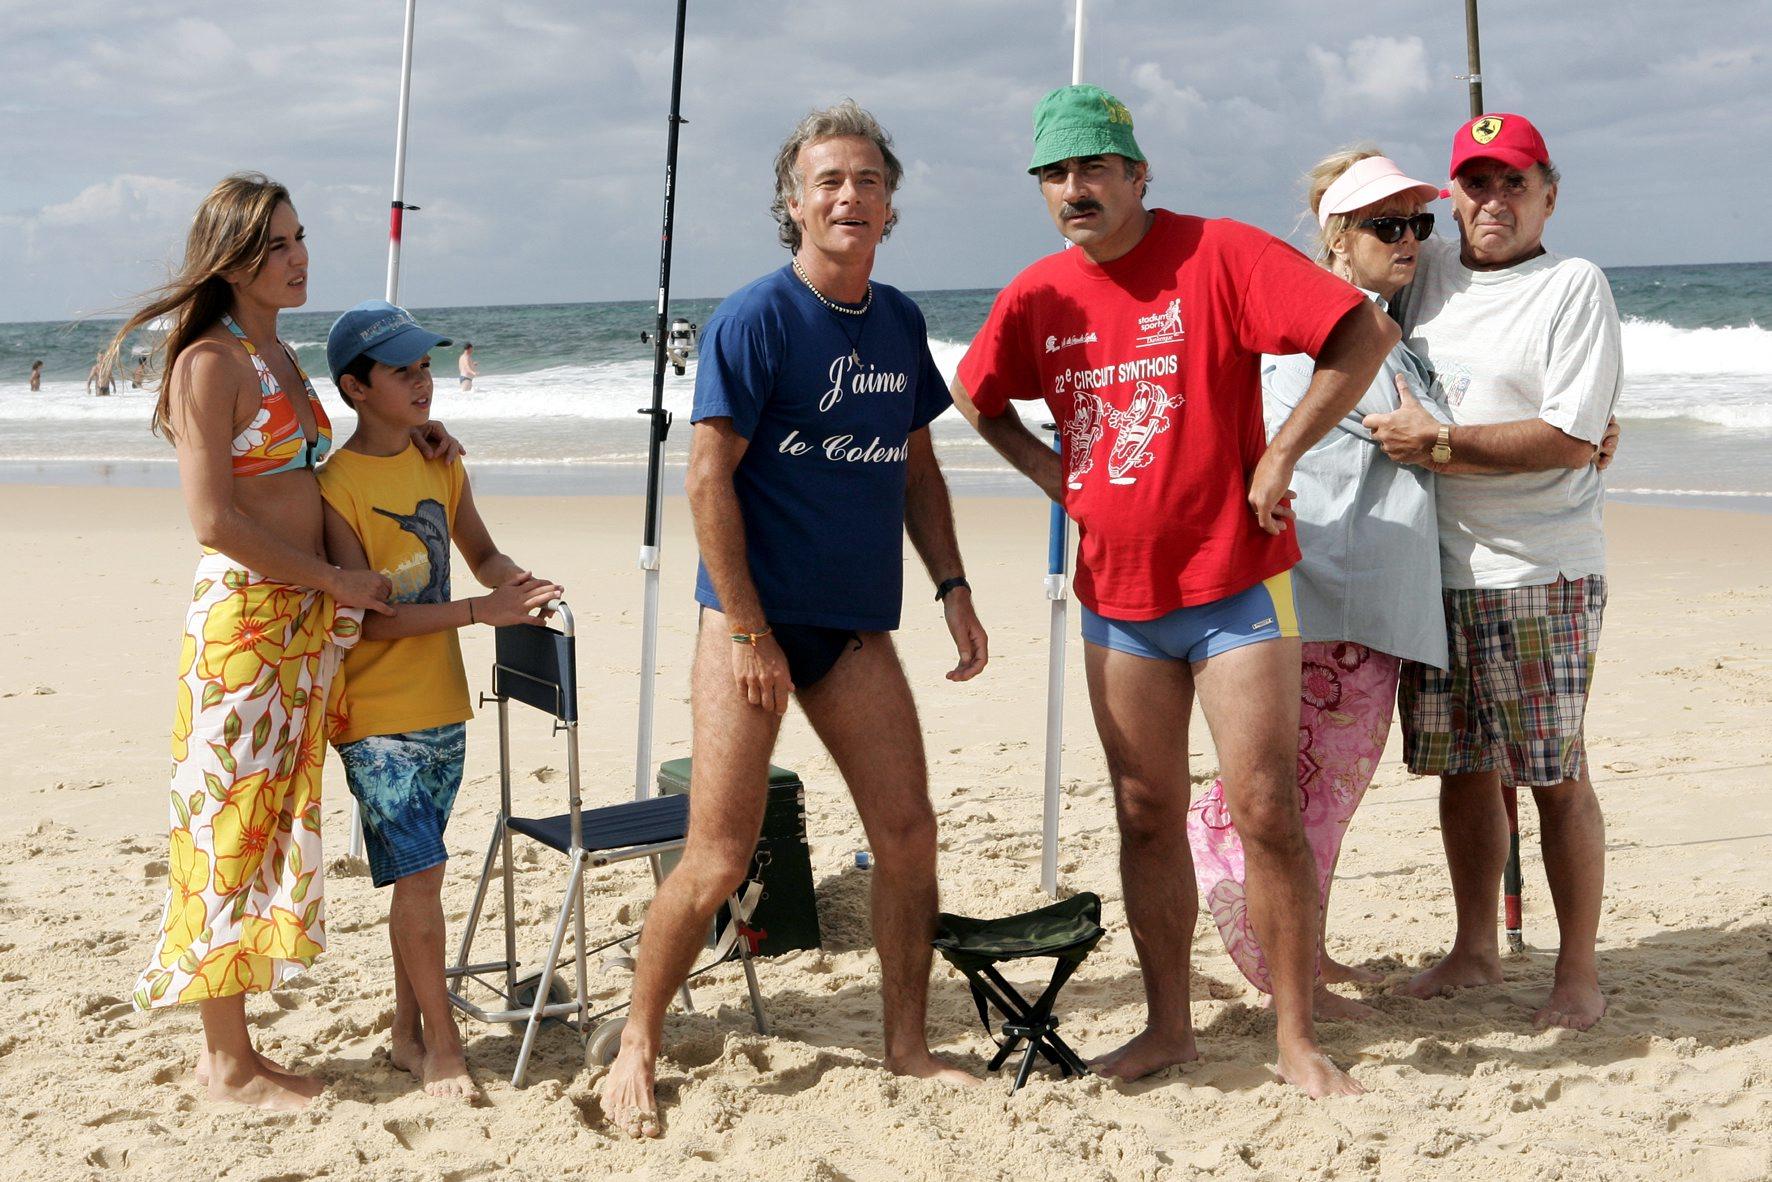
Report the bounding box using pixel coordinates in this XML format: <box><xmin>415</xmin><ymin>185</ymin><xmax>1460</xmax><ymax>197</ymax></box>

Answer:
<box><xmin>0</xmin><ymin>262</ymin><xmax>1772</xmax><ymax>512</ymax></box>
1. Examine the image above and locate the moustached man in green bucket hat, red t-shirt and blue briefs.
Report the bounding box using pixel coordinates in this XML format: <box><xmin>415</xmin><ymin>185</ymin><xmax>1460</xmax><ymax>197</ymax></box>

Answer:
<box><xmin>953</xmin><ymin>87</ymin><xmax>1398</xmax><ymax>1097</ymax></box>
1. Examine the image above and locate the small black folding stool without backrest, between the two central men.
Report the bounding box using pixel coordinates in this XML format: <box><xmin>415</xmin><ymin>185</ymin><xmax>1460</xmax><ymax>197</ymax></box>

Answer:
<box><xmin>934</xmin><ymin>891</ymin><xmax>1102</xmax><ymax>1095</ymax></box>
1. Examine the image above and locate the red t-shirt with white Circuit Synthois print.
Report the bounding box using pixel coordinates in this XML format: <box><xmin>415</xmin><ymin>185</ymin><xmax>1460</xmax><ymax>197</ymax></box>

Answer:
<box><xmin>959</xmin><ymin>209</ymin><xmax>1364</xmax><ymax>620</ymax></box>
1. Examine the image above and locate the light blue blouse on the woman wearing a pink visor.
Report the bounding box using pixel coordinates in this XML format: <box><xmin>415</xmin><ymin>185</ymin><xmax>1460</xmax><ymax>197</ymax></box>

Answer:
<box><xmin>1262</xmin><ymin>292</ymin><xmax>1451</xmax><ymax>668</ymax></box>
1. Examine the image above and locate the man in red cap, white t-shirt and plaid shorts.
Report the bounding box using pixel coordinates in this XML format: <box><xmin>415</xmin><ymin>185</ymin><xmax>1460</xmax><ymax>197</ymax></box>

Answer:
<box><xmin>1366</xmin><ymin>113</ymin><xmax>1623</xmax><ymax>1030</ymax></box>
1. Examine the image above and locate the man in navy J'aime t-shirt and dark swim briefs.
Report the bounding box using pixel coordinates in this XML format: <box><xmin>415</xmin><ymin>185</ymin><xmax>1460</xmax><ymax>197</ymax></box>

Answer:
<box><xmin>602</xmin><ymin>101</ymin><xmax>987</xmax><ymax>1136</ymax></box>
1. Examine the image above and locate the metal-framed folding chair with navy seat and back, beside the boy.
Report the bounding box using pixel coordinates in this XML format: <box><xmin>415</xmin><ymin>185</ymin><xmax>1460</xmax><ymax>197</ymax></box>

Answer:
<box><xmin>445</xmin><ymin>601</ymin><xmax>769</xmax><ymax>1088</ymax></box>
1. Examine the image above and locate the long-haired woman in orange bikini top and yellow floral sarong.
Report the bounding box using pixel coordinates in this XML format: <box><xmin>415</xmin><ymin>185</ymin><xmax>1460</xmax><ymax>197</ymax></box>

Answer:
<box><xmin>110</xmin><ymin>174</ymin><xmax>404</xmax><ymax>1109</ymax></box>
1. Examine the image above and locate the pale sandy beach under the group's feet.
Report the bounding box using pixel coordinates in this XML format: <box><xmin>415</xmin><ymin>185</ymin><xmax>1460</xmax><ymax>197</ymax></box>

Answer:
<box><xmin>0</xmin><ymin>478</ymin><xmax>1772</xmax><ymax>1182</ymax></box>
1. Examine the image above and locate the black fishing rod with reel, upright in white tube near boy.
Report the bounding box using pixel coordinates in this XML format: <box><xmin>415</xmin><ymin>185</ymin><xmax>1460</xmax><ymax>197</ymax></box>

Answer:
<box><xmin>634</xmin><ymin>0</ymin><xmax>689</xmax><ymax>799</ymax></box>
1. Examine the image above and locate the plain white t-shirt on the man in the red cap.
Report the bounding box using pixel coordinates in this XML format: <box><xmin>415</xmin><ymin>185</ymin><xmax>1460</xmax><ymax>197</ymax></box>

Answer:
<box><xmin>1398</xmin><ymin>237</ymin><xmax>1623</xmax><ymax>588</ymax></box>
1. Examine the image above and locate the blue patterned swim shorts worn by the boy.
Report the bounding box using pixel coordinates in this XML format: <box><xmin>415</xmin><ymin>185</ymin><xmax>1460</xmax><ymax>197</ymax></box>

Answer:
<box><xmin>338</xmin><ymin>723</ymin><xmax>468</xmax><ymax>886</ymax></box>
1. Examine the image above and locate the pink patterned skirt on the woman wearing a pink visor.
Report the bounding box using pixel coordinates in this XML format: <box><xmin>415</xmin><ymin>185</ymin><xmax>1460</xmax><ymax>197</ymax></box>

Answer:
<box><xmin>1187</xmin><ymin>640</ymin><xmax>1398</xmax><ymax>992</ymax></box>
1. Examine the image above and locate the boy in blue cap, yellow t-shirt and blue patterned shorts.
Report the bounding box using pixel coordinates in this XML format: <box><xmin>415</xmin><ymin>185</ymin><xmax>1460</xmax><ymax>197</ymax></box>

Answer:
<box><xmin>319</xmin><ymin>299</ymin><xmax>560</xmax><ymax>1100</ymax></box>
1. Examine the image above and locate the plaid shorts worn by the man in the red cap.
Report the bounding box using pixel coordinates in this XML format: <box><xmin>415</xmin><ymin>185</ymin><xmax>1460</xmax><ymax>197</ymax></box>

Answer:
<box><xmin>1396</xmin><ymin>574</ymin><xmax>1605</xmax><ymax>789</ymax></box>
